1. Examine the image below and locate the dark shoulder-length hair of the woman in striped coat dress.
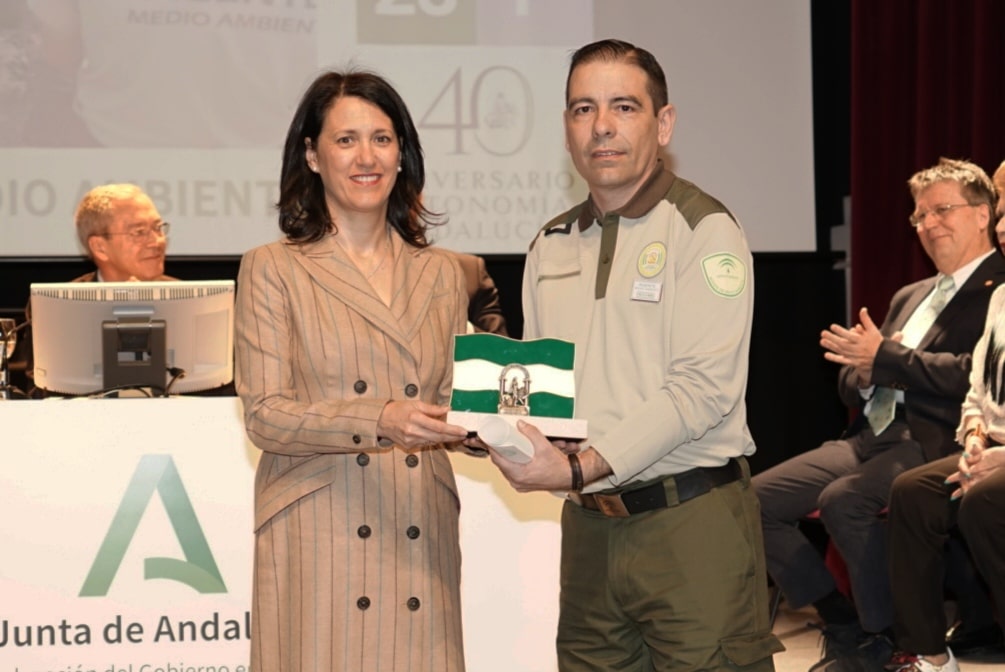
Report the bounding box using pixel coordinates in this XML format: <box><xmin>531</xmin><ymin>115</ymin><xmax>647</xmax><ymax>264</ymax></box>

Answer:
<box><xmin>276</xmin><ymin>71</ymin><xmax>441</xmax><ymax>247</ymax></box>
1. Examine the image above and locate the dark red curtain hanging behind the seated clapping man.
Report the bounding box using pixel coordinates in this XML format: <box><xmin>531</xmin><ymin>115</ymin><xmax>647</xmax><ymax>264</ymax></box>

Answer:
<box><xmin>850</xmin><ymin>0</ymin><xmax>1005</xmax><ymax>323</ymax></box>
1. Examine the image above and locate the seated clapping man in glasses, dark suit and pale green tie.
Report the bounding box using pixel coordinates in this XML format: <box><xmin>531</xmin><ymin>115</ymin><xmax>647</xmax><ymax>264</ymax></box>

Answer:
<box><xmin>753</xmin><ymin>159</ymin><xmax>1005</xmax><ymax>672</ymax></box>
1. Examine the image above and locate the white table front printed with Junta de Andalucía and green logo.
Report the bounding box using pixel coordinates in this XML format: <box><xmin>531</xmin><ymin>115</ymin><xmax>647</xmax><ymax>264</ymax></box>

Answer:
<box><xmin>0</xmin><ymin>398</ymin><xmax>561</xmax><ymax>672</ymax></box>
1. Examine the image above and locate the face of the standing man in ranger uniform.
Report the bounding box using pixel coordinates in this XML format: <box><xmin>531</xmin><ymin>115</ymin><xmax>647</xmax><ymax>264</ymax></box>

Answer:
<box><xmin>565</xmin><ymin>61</ymin><xmax>674</xmax><ymax>212</ymax></box>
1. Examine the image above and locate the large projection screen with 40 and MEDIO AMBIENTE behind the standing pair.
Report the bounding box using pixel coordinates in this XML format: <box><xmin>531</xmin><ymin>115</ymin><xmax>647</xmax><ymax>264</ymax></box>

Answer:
<box><xmin>0</xmin><ymin>0</ymin><xmax>815</xmax><ymax>256</ymax></box>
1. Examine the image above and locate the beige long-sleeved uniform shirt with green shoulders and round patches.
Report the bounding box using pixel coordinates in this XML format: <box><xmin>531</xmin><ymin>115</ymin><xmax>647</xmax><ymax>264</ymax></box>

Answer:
<box><xmin>524</xmin><ymin>160</ymin><xmax>755</xmax><ymax>491</ymax></box>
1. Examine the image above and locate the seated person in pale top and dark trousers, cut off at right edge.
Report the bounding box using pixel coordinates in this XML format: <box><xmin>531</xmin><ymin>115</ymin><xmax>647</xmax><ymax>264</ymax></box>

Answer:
<box><xmin>887</xmin><ymin>162</ymin><xmax>1005</xmax><ymax>672</ymax></box>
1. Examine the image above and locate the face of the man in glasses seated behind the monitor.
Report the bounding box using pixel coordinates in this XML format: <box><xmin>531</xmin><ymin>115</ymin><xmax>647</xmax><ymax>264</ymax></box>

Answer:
<box><xmin>87</xmin><ymin>196</ymin><xmax>168</xmax><ymax>282</ymax></box>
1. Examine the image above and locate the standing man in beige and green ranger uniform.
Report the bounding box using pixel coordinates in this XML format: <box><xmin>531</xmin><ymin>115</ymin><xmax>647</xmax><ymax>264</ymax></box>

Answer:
<box><xmin>482</xmin><ymin>40</ymin><xmax>782</xmax><ymax>672</ymax></box>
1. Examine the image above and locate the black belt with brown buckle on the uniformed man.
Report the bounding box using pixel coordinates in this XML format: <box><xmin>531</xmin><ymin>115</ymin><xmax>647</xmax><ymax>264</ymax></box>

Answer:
<box><xmin>569</xmin><ymin>458</ymin><xmax>744</xmax><ymax>518</ymax></box>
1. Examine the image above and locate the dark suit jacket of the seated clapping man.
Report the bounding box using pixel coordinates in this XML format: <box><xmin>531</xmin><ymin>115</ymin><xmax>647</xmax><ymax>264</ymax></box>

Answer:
<box><xmin>838</xmin><ymin>252</ymin><xmax>1005</xmax><ymax>461</ymax></box>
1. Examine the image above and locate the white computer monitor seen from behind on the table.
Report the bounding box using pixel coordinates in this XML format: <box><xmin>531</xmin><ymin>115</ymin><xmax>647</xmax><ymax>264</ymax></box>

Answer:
<box><xmin>31</xmin><ymin>280</ymin><xmax>234</xmax><ymax>396</ymax></box>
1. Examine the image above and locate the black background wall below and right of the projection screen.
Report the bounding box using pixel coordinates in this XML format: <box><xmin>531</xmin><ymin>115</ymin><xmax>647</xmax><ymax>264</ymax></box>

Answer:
<box><xmin>0</xmin><ymin>0</ymin><xmax>850</xmax><ymax>471</ymax></box>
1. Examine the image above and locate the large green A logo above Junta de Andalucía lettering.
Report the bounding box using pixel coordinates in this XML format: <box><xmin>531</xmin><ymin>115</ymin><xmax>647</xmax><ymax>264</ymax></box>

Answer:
<box><xmin>80</xmin><ymin>455</ymin><xmax>227</xmax><ymax>598</ymax></box>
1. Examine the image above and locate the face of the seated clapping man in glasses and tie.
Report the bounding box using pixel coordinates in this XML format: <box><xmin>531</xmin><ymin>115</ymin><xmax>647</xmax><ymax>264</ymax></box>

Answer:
<box><xmin>915</xmin><ymin>180</ymin><xmax>991</xmax><ymax>274</ymax></box>
